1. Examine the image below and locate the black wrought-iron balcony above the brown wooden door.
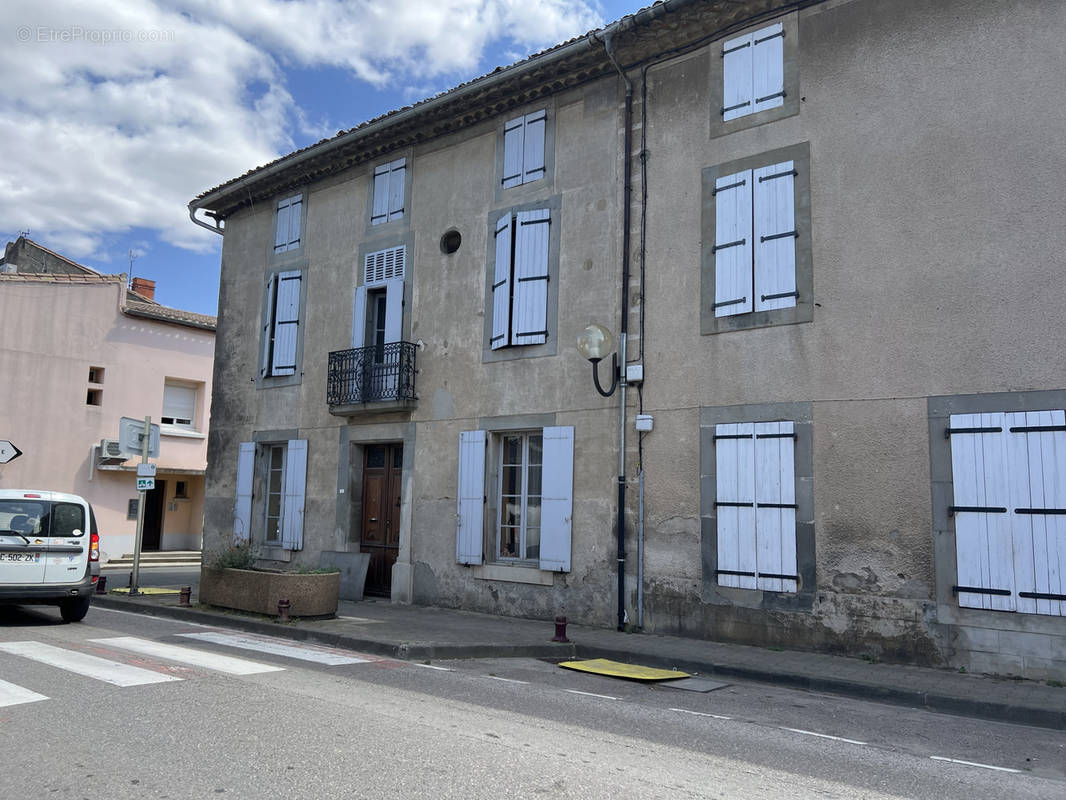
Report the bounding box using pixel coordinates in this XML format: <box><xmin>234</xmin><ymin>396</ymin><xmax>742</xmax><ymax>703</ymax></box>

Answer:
<box><xmin>326</xmin><ymin>341</ymin><xmax>418</xmax><ymax>416</ymax></box>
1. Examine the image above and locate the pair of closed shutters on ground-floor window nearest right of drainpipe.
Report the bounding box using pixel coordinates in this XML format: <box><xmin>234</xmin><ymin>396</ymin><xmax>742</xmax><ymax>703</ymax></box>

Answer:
<box><xmin>714</xmin><ymin>421</ymin><xmax>798</xmax><ymax>592</ymax></box>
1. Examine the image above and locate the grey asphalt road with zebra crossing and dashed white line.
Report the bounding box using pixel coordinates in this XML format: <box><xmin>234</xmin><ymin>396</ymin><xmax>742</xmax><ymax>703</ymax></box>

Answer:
<box><xmin>0</xmin><ymin>607</ymin><xmax>1066</xmax><ymax>800</ymax></box>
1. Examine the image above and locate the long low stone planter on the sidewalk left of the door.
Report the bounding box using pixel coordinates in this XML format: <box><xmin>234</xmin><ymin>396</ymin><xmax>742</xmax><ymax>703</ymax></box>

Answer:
<box><xmin>199</xmin><ymin>566</ymin><xmax>340</xmax><ymax>617</ymax></box>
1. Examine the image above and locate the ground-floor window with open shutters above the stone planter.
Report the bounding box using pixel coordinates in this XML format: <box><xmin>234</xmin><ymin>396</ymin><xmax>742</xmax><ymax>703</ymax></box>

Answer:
<box><xmin>233</xmin><ymin>439</ymin><xmax>307</xmax><ymax>550</ymax></box>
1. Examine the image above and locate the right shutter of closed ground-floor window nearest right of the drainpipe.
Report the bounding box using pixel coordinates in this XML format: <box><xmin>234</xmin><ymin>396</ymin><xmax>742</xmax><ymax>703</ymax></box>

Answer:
<box><xmin>755</xmin><ymin>422</ymin><xmax>797</xmax><ymax>592</ymax></box>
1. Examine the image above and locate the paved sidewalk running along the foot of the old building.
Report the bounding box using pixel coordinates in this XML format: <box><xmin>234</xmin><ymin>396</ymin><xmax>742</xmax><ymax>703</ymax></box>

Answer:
<box><xmin>91</xmin><ymin>588</ymin><xmax>1066</xmax><ymax>730</ymax></box>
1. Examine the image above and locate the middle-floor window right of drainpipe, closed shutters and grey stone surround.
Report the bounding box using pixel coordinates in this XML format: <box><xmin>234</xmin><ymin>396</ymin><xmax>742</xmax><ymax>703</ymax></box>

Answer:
<box><xmin>700</xmin><ymin>144</ymin><xmax>813</xmax><ymax>334</ymax></box>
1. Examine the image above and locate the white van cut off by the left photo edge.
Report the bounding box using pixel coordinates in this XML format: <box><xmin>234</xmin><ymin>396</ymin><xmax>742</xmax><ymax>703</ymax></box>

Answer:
<box><xmin>0</xmin><ymin>489</ymin><xmax>100</xmax><ymax>622</ymax></box>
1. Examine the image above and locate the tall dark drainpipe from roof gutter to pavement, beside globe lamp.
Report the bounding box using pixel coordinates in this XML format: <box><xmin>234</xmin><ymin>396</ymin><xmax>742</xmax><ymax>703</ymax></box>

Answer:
<box><xmin>593</xmin><ymin>26</ymin><xmax>633</xmax><ymax>630</ymax></box>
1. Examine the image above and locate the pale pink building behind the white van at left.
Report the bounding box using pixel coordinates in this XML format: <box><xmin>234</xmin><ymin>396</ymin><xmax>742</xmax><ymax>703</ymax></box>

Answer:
<box><xmin>0</xmin><ymin>237</ymin><xmax>215</xmax><ymax>561</ymax></box>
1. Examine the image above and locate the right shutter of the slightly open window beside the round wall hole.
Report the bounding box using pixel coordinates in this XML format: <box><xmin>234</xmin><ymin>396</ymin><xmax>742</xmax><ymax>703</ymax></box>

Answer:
<box><xmin>511</xmin><ymin>208</ymin><xmax>551</xmax><ymax>345</ymax></box>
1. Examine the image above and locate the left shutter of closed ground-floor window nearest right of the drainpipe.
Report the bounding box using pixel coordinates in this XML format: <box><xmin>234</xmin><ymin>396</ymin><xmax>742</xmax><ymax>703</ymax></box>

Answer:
<box><xmin>714</xmin><ymin>422</ymin><xmax>756</xmax><ymax>589</ymax></box>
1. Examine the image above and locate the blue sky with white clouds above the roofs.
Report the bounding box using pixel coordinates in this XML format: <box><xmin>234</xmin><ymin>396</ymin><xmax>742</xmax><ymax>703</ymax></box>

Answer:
<box><xmin>0</xmin><ymin>0</ymin><xmax>651</xmax><ymax>315</ymax></box>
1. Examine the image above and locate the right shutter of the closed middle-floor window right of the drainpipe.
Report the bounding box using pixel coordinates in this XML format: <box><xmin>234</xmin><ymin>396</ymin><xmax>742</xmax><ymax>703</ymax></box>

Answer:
<box><xmin>752</xmin><ymin>161</ymin><xmax>797</xmax><ymax>311</ymax></box>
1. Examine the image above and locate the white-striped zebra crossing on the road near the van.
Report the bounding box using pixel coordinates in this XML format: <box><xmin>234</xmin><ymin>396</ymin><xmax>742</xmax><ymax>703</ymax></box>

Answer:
<box><xmin>0</xmin><ymin>630</ymin><xmax>383</xmax><ymax>708</ymax></box>
